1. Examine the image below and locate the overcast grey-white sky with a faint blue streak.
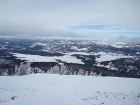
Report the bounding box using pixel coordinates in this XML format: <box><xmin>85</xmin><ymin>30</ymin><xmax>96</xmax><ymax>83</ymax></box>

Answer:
<box><xmin>0</xmin><ymin>0</ymin><xmax>140</xmax><ymax>41</ymax></box>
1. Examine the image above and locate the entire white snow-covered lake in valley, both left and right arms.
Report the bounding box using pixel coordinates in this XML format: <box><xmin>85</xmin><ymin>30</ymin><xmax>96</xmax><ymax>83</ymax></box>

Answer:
<box><xmin>12</xmin><ymin>52</ymin><xmax>132</xmax><ymax>64</ymax></box>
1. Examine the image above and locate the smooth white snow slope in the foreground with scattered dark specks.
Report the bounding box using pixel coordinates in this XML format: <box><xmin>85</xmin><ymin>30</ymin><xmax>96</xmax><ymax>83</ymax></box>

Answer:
<box><xmin>0</xmin><ymin>74</ymin><xmax>140</xmax><ymax>105</ymax></box>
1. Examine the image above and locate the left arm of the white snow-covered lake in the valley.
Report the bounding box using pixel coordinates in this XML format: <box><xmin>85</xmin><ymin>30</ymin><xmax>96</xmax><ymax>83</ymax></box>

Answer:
<box><xmin>13</xmin><ymin>53</ymin><xmax>84</xmax><ymax>64</ymax></box>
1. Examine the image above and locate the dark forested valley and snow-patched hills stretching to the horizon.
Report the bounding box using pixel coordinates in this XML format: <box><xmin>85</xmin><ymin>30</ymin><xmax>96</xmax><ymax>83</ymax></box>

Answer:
<box><xmin>0</xmin><ymin>39</ymin><xmax>140</xmax><ymax>78</ymax></box>
